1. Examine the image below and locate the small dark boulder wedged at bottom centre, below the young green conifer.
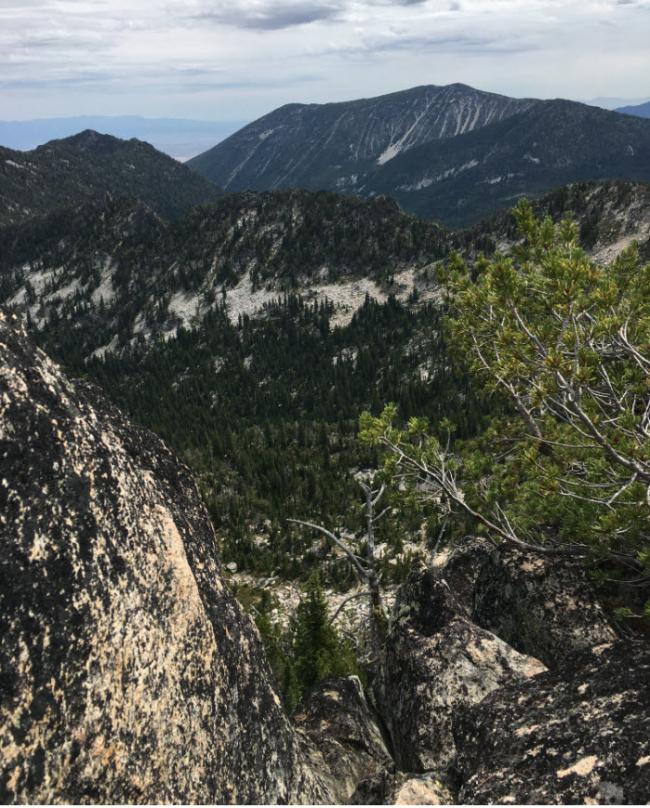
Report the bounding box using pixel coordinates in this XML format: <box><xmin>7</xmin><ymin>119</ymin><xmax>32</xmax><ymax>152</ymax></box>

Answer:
<box><xmin>294</xmin><ymin>676</ymin><xmax>392</xmax><ymax>803</ymax></box>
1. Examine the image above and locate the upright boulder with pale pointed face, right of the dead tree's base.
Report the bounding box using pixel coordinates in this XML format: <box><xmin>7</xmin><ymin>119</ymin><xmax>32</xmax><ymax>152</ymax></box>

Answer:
<box><xmin>375</xmin><ymin>569</ymin><xmax>545</xmax><ymax>772</ymax></box>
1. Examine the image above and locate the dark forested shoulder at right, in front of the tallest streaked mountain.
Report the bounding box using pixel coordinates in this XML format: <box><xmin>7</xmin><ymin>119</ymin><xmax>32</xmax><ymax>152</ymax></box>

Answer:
<box><xmin>362</xmin><ymin>101</ymin><xmax>650</xmax><ymax>225</ymax></box>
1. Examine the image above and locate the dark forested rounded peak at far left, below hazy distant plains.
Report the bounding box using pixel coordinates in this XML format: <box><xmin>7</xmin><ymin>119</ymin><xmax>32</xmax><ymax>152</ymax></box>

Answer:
<box><xmin>0</xmin><ymin>130</ymin><xmax>220</xmax><ymax>225</ymax></box>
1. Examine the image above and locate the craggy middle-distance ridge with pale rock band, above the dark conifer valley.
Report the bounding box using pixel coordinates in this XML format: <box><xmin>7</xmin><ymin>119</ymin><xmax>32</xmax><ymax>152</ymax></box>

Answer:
<box><xmin>0</xmin><ymin>191</ymin><xmax>448</xmax><ymax>357</ymax></box>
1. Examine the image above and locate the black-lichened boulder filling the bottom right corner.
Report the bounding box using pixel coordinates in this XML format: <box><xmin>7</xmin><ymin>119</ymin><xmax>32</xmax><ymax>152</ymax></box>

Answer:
<box><xmin>454</xmin><ymin>641</ymin><xmax>650</xmax><ymax>804</ymax></box>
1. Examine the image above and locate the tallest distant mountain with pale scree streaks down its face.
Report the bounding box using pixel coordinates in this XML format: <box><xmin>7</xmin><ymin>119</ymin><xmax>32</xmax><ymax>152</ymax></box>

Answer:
<box><xmin>188</xmin><ymin>84</ymin><xmax>535</xmax><ymax>192</ymax></box>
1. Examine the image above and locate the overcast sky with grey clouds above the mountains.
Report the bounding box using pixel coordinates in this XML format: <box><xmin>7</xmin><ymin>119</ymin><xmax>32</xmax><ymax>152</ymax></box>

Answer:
<box><xmin>0</xmin><ymin>0</ymin><xmax>650</xmax><ymax>121</ymax></box>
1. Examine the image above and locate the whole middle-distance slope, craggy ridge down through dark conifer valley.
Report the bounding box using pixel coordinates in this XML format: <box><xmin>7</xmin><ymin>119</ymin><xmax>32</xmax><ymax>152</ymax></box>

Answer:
<box><xmin>0</xmin><ymin>183</ymin><xmax>650</xmax><ymax>584</ymax></box>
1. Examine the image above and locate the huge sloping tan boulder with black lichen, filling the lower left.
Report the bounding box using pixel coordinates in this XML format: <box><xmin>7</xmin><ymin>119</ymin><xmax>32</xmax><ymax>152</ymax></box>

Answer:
<box><xmin>0</xmin><ymin>314</ymin><xmax>331</xmax><ymax>803</ymax></box>
